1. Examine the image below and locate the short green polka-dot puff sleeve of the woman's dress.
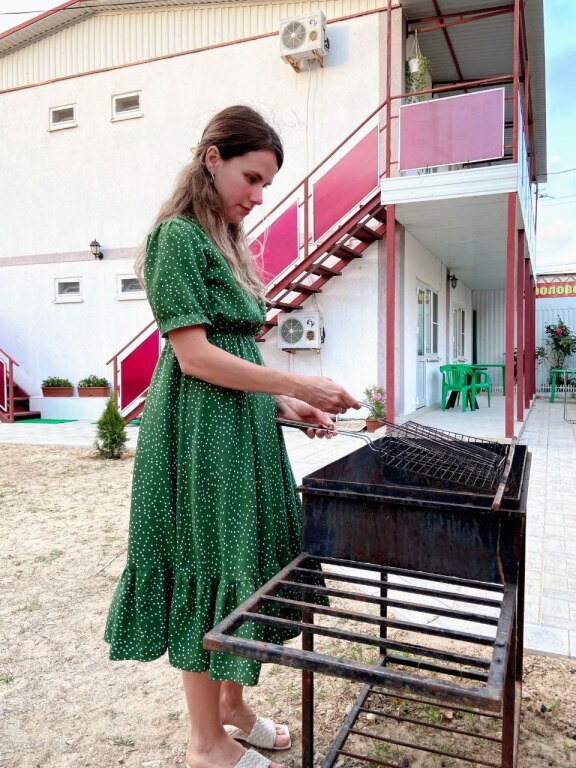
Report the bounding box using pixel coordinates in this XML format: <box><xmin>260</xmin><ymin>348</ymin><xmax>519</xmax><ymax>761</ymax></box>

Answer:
<box><xmin>144</xmin><ymin>218</ymin><xmax>211</xmax><ymax>336</ymax></box>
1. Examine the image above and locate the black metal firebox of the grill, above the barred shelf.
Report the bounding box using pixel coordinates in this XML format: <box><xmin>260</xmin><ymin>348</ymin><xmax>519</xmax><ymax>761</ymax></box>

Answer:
<box><xmin>300</xmin><ymin>438</ymin><xmax>527</xmax><ymax>584</ymax></box>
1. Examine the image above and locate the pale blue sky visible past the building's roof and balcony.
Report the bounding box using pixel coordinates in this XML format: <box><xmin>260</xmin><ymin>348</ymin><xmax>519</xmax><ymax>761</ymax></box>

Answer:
<box><xmin>0</xmin><ymin>0</ymin><xmax>576</xmax><ymax>272</ymax></box>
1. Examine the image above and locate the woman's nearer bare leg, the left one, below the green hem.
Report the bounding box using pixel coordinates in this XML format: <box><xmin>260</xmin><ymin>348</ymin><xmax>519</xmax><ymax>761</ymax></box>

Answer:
<box><xmin>182</xmin><ymin>672</ymin><xmax>284</xmax><ymax>768</ymax></box>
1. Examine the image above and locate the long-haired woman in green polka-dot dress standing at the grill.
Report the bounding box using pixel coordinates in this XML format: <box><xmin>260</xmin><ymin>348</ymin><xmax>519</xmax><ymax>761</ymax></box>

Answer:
<box><xmin>106</xmin><ymin>106</ymin><xmax>359</xmax><ymax>768</ymax></box>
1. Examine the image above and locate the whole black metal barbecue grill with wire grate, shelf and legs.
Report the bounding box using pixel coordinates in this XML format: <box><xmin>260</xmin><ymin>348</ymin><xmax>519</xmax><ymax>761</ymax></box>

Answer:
<box><xmin>204</xmin><ymin>430</ymin><xmax>530</xmax><ymax>768</ymax></box>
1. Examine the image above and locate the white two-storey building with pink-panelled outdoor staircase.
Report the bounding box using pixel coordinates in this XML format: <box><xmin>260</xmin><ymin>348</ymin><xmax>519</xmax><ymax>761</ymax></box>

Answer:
<box><xmin>0</xmin><ymin>0</ymin><xmax>546</xmax><ymax>435</ymax></box>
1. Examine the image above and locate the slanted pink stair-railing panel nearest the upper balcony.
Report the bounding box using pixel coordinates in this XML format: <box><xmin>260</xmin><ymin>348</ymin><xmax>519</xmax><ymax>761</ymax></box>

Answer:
<box><xmin>313</xmin><ymin>127</ymin><xmax>378</xmax><ymax>240</ymax></box>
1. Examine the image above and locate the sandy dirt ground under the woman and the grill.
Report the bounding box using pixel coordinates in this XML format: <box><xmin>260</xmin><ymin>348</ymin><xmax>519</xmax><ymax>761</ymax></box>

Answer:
<box><xmin>0</xmin><ymin>445</ymin><xmax>576</xmax><ymax>768</ymax></box>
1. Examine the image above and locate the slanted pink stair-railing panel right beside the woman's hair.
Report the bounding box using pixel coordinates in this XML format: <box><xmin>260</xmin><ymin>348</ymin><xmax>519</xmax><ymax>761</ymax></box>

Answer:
<box><xmin>250</xmin><ymin>201</ymin><xmax>298</xmax><ymax>284</ymax></box>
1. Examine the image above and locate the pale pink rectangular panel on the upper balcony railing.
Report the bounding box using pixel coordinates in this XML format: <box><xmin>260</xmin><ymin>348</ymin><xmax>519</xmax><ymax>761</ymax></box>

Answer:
<box><xmin>400</xmin><ymin>88</ymin><xmax>504</xmax><ymax>171</ymax></box>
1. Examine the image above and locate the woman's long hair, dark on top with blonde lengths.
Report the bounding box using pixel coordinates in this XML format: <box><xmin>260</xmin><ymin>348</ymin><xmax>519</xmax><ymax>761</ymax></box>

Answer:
<box><xmin>134</xmin><ymin>106</ymin><xmax>284</xmax><ymax>299</ymax></box>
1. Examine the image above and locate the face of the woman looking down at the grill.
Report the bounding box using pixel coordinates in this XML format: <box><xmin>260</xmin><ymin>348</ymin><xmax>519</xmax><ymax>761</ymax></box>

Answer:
<box><xmin>206</xmin><ymin>147</ymin><xmax>278</xmax><ymax>224</ymax></box>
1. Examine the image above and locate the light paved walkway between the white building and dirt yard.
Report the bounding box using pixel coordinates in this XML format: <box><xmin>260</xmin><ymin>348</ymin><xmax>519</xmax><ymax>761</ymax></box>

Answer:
<box><xmin>0</xmin><ymin>399</ymin><xmax>576</xmax><ymax>658</ymax></box>
